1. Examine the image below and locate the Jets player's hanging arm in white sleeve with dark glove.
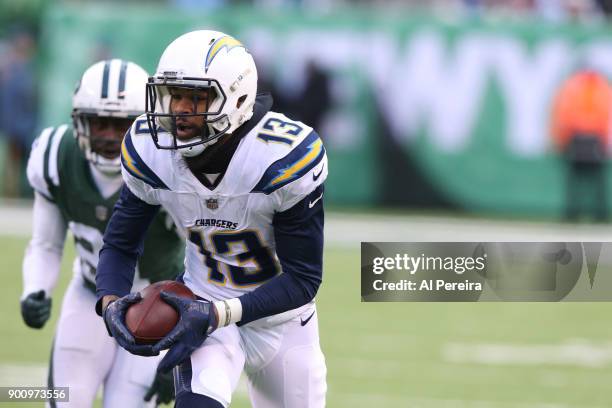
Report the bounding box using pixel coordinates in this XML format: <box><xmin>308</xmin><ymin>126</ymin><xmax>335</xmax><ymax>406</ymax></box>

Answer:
<box><xmin>21</xmin><ymin>192</ymin><xmax>67</xmax><ymax>329</ymax></box>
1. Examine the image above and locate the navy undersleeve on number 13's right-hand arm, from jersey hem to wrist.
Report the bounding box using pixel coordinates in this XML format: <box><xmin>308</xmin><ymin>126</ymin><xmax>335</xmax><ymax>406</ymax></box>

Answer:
<box><xmin>239</xmin><ymin>185</ymin><xmax>324</xmax><ymax>325</ymax></box>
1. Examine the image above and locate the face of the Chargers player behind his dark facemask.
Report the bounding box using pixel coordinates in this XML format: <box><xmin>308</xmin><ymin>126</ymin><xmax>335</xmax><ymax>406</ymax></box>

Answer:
<box><xmin>169</xmin><ymin>87</ymin><xmax>212</xmax><ymax>140</ymax></box>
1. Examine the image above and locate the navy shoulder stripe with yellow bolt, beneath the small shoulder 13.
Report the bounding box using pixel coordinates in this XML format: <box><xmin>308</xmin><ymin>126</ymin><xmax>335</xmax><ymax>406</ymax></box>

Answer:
<box><xmin>251</xmin><ymin>131</ymin><xmax>325</xmax><ymax>194</ymax></box>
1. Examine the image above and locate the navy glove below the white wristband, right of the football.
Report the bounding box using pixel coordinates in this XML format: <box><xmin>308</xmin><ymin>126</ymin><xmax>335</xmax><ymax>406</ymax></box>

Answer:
<box><xmin>153</xmin><ymin>291</ymin><xmax>218</xmax><ymax>372</ymax></box>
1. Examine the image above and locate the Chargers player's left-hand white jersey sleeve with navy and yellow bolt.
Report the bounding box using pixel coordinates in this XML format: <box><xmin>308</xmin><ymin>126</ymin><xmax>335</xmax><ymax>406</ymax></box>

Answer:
<box><xmin>121</xmin><ymin>119</ymin><xmax>168</xmax><ymax>205</ymax></box>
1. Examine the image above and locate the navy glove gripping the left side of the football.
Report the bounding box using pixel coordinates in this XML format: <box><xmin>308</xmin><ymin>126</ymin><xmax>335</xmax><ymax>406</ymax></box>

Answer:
<box><xmin>104</xmin><ymin>293</ymin><xmax>159</xmax><ymax>356</ymax></box>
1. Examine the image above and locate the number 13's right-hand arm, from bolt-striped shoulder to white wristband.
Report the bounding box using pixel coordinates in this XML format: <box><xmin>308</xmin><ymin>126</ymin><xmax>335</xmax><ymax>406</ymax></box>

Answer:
<box><xmin>240</xmin><ymin>131</ymin><xmax>327</xmax><ymax>324</ymax></box>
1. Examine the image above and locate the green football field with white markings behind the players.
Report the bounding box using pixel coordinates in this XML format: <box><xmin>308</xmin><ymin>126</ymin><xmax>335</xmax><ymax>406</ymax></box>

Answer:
<box><xmin>0</xmin><ymin>233</ymin><xmax>612</xmax><ymax>408</ymax></box>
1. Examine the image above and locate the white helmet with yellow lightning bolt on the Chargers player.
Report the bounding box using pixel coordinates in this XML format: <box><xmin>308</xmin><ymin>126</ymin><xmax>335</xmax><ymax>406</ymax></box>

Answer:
<box><xmin>146</xmin><ymin>30</ymin><xmax>257</xmax><ymax>156</ymax></box>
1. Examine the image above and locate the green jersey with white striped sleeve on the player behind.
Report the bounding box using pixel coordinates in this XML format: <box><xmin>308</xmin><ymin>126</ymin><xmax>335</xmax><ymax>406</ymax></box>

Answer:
<box><xmin>28</xmin><ymin>125</ymin><xmax>184</xmax><ymax>290</ymax></box>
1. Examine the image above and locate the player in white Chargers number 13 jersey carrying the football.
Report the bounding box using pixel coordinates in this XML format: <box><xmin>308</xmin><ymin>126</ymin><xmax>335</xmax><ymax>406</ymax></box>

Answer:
<box><xmin>96</xmin><ymin>30</ymin><xmax>327</xmax><ymax>408</ymax></box>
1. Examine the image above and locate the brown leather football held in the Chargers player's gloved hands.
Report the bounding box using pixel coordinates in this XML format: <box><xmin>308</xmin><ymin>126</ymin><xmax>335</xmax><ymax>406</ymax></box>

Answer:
<box><xmin>125</xmin><ymin>280</ymin><xmax>196</xmax><ymax>344</ymax></box>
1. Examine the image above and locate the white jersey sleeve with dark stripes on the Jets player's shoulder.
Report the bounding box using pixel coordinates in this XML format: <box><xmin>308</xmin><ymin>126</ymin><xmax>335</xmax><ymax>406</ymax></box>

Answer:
<box><xmin>27</xmin><ymin>125</ymin><xmax>68</xmax><ymax>201</ymax></box>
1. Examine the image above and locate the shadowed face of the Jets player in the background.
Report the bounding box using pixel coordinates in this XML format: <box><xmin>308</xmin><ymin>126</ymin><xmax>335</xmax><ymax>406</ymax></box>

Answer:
<box><xmin>89</xmin><ymin>116</ymin><xmax>133</xmax><ymax>159</ymax></box>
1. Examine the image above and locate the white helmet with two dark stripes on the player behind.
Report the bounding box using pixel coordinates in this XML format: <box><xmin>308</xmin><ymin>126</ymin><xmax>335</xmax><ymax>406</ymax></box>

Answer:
<box><xmin>72</xmin><ymin>59</ymin><xmax>149</xmax><ymax>174</ymax></box>
